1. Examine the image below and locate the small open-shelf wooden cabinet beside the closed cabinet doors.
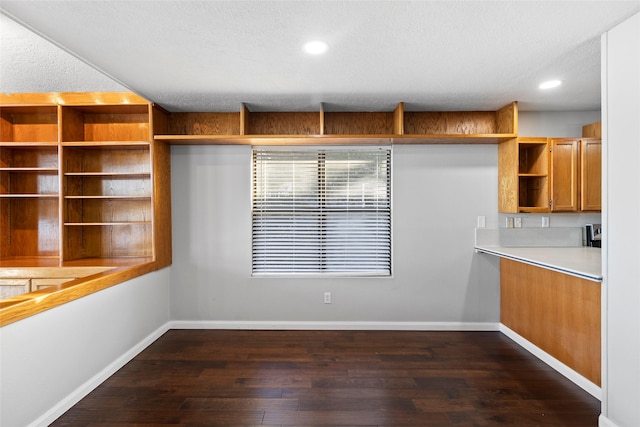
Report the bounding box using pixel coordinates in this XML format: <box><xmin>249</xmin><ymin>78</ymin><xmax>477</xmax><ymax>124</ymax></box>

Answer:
<box><xmin>498</xmin><ymin>137</ymin><xmax>549</xmax><ymax>213</ymax></box>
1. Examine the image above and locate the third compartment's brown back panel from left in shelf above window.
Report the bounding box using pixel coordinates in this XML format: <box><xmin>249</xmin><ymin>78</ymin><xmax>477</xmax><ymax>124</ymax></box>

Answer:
<box><xmin>324</xmin><ymin>111</ymin><xmax>394</xmax><ymax>135</ymax></box>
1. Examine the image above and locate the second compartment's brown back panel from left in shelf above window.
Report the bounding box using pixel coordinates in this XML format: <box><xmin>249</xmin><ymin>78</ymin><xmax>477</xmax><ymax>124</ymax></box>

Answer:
<box><xmin>249</xmin><ymin>112</ymin><xmax>320</xmax><ymax>135</ymax></box>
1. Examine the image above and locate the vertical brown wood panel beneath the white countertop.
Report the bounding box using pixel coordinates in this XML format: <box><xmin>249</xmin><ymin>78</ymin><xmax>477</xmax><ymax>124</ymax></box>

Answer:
<box><xmin>500</xmin><ymin>258</ymin><xmax>601</xmax><ymax>385</ymax></box>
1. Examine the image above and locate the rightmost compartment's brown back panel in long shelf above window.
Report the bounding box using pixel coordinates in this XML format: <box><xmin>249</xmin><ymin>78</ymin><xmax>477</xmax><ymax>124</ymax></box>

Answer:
<box><xmin>404</xmin><ymin>111</ymin><xmax>497</xmax><ymax>135</ymax></box>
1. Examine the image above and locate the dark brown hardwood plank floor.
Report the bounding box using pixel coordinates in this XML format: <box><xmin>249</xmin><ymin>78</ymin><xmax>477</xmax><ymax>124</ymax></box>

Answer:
<box><xmin>52</xmin><ymin>330</ymin><xmax>600</xmax><ymax>427</ymax></box>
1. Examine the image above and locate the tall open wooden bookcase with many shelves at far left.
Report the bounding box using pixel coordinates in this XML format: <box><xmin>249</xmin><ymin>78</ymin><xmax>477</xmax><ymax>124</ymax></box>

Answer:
<box><xmin>0</xmin><ymin>93</ymin><xmax>171</xmax><ymax>266</ymax></box>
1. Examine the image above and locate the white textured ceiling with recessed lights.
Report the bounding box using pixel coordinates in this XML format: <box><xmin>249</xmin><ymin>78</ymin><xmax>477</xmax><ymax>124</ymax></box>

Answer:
<box><xmin>0</xmin><ymin>0</ymin><xmax>640</xmax><ymax>111</ymax></box>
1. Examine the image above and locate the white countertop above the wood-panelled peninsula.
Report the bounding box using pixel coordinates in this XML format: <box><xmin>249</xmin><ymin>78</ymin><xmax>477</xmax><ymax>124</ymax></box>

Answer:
<box><xmin>475</xmin><ymin>245</ymin><xmax>602</xmax><ymax>282</ymax></box>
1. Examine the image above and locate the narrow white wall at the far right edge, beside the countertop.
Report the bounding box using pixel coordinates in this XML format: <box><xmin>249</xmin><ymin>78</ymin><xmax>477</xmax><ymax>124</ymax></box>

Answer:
<box><xmin>600</xmin><ymin>14</ymin><xmax>640</xmax><ymax>427</ymax></box>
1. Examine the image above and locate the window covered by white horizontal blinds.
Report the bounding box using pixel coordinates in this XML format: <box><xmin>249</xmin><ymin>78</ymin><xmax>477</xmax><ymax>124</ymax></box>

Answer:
<box><xmin>252</xmin><ymin>147</ymin><xmax>391</xmax><ymax>276</ymax></box>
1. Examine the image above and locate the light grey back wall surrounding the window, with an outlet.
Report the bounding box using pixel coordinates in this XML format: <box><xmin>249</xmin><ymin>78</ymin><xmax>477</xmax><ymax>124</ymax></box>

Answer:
<box><xmin>171</xmin><ymin>145</ymin><xmax>499</xmax><ymax>328</ymax></box>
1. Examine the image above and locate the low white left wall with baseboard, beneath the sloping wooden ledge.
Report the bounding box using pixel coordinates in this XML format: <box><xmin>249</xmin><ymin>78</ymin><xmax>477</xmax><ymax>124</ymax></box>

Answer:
<box><xmin>0</xmin><ymin>268</ymin><xmax>170</xmax><ymax>427</ymax></box>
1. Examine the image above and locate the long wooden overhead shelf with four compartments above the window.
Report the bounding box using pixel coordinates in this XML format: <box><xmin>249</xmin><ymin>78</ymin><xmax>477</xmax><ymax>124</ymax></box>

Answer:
<box><xmin>154</xmin><ymin>102</ymin><xmax>518</xmax><ymax>145</ymax></box>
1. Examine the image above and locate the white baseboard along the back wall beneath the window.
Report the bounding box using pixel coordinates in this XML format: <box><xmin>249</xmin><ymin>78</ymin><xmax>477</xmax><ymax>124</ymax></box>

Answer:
<box><xmin>169</xmin><ymin>320</ymin><xmax>500</xmax><ymax>331</ymax></box>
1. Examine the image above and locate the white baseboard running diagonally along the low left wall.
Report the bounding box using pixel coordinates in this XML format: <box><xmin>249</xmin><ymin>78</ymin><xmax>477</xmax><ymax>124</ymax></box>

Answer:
<box><xmin>29</xmin><ymin>323</ymin><xmax>170</xmax><ymax>427</ymax></box>
